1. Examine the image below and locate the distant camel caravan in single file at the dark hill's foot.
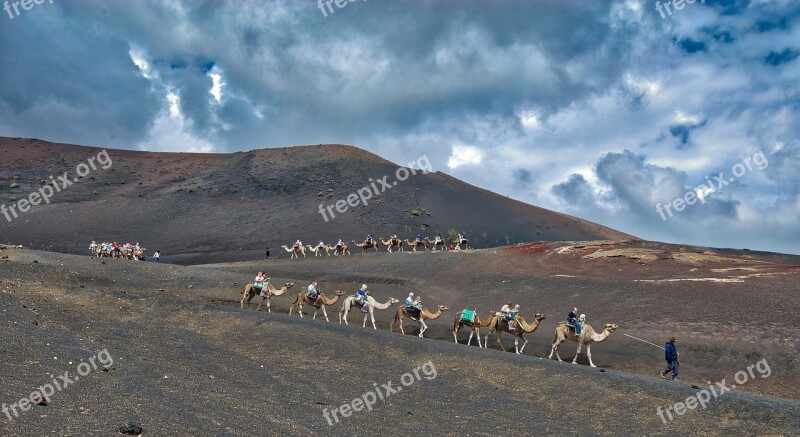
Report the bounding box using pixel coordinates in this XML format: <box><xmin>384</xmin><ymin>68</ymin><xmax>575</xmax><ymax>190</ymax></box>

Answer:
<box><xmin>281</xmin><ymin>234</ymin><xmax>472</xmax><ymax>259</ymax></box>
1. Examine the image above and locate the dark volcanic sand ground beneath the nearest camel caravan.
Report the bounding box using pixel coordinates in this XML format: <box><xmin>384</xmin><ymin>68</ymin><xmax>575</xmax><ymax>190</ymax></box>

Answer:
<box><xmin>0</xmin><ymin>244</ymin><xmax>800</xmax><ymax>436</ymax></box>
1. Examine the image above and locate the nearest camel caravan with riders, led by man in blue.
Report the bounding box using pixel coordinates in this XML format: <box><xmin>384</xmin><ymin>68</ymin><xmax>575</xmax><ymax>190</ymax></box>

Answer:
<box><xmin>241</xmin><ymin>272</ymin><xmax>618</xmax><ymax>367</ymax></box>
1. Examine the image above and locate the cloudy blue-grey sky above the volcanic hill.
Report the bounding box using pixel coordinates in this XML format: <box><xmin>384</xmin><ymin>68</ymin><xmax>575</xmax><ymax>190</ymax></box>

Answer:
<box><xmin>0</xmin><ymin>0</ymin><xmax>800</xmax><ymax>254</ymax></box>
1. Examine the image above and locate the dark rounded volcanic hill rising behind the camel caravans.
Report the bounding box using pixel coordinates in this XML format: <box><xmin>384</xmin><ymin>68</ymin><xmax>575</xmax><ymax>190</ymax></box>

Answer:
<box><xmin>0</xmin><ymin>138</ymin><xmax>630</xmax><ymax>263</ymax></box>
